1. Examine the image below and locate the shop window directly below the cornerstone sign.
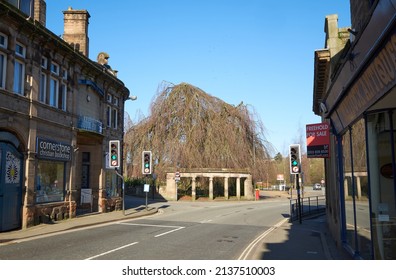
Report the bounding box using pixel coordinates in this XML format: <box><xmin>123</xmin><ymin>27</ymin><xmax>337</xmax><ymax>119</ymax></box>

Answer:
<box><xmin>36</xmin><ymin>160</ymin><xmax>65</xmax><ymax>203</ymax></box>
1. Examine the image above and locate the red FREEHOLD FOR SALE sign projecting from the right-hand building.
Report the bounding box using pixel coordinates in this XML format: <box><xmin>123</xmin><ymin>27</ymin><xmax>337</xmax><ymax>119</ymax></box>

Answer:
<box><xmin>307</xmin><ymin>123</ymin><xmax>330</xmax><ymax>158</ymax></box>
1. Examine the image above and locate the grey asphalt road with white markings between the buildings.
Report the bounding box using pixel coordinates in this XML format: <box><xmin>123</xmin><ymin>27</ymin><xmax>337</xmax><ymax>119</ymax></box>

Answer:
<box><xmin>0</xmin><ymin>200</ymin><xmax>289</xmax><ymax>260</ymax></box>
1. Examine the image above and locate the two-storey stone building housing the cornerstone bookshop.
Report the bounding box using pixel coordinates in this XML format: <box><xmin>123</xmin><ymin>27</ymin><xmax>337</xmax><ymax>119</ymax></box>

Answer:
<box><xmin>0</xmin><ymin>0</ymin><xmax>129</xmax><ymax>231</ymax></box>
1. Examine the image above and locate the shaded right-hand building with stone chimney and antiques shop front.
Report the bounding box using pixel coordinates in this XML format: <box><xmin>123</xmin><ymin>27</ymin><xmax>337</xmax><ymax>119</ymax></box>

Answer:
<box><xmin>313</xmin><ymin>0</ymin><xmax>396</xmax><ymax>259</ymax></box>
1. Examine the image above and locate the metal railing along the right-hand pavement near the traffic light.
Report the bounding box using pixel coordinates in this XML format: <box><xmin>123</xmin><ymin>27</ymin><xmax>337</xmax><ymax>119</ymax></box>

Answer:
<box><xmin>290</xmin><ymin>196</ymin><xmax>326</xmax><ymax>221</ymax></box>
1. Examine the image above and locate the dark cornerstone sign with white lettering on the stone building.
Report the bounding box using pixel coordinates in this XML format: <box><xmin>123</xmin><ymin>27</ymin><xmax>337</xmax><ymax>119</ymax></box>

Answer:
<box><xmin>36</xmin><ymin>137</ymin><xmax>73</xmax><ymax>161</ymax></box>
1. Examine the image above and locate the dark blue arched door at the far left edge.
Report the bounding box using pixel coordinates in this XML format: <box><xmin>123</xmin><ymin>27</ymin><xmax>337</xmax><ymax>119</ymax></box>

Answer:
<box><xmin>0</xmin><ymin>142</ymin><xmax>23</xmax><ymax>232</ymax></box>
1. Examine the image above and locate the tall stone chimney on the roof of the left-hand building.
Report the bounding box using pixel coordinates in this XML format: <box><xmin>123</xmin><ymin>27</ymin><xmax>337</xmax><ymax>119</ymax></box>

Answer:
<box><xmin>63</xmin><ymin>7</ymin><xmax>90</xmax><ymax>57</ymax></box>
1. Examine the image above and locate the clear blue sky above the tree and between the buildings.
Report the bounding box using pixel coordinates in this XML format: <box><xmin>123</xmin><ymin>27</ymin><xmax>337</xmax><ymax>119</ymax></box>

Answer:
<box><xmin>46</xmin><ymin>0</ymin><xmax>350</xmax><ymax>154</ymax></box>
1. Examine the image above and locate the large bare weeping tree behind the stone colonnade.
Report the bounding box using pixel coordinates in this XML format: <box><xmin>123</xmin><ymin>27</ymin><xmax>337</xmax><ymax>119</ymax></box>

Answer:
<box><xmin>125</xmin><ymin>83</ymin><xmax>271</xmax><ymax>183</ymax></box>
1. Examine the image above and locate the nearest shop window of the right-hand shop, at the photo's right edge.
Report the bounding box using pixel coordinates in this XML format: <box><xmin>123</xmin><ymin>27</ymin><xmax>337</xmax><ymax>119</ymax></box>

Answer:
<box><xmin>367</xmin><ymin>111</ymin><xmax>396</xmax><ymax>260</ymax></box>
